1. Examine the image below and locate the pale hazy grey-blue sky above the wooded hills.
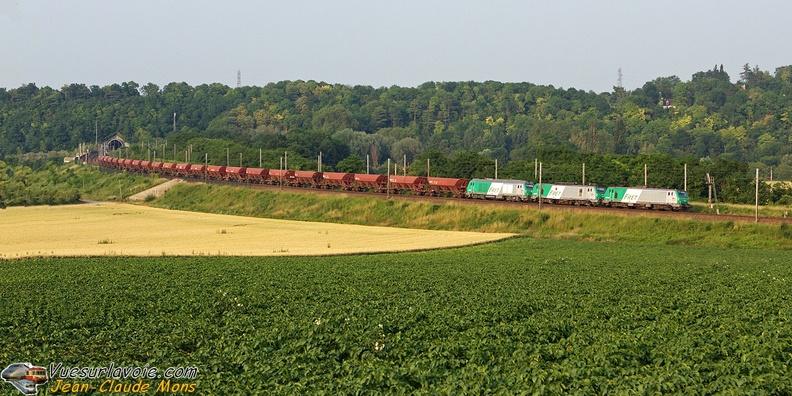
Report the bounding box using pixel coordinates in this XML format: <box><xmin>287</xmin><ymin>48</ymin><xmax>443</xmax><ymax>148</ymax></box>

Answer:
<box><xmin>0</xmin><ymin>0</ymin><xmax>792</xmax><ymax>93</ymax></box>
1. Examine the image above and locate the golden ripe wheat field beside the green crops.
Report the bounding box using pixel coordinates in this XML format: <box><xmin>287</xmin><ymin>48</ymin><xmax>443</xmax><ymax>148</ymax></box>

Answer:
<box><xmin>0</xmin><ymin>203</ymin><xmax>512</xmax><ymax>259</ymax></box>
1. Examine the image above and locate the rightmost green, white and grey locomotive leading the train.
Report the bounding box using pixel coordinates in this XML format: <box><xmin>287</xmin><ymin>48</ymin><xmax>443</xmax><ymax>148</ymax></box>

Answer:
<box><xmin>604</xmin><ymin>187</ymin><xmax>690</xmax><ymax>210</ymax></box>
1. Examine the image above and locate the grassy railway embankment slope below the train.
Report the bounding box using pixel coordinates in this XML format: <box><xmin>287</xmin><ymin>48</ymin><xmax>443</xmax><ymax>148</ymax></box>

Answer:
<box><xmin>150</xmin><ymin>183</ymin><xmax>792</xmax><ymax>249</ymax></box>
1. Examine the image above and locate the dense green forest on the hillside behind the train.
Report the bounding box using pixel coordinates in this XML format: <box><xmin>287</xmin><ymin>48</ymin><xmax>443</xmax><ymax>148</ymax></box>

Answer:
<box><xmin>0</xmin><ymin>65</ymin><xmax>792</xmax><ymax>202</ymax></box>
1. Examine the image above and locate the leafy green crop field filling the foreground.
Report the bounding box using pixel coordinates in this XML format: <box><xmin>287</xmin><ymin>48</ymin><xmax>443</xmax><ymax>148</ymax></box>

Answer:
<box><xmin>0</xmin><ymin>238</ymin><xmax>792</xmax><ymax>395</ymax></box>
